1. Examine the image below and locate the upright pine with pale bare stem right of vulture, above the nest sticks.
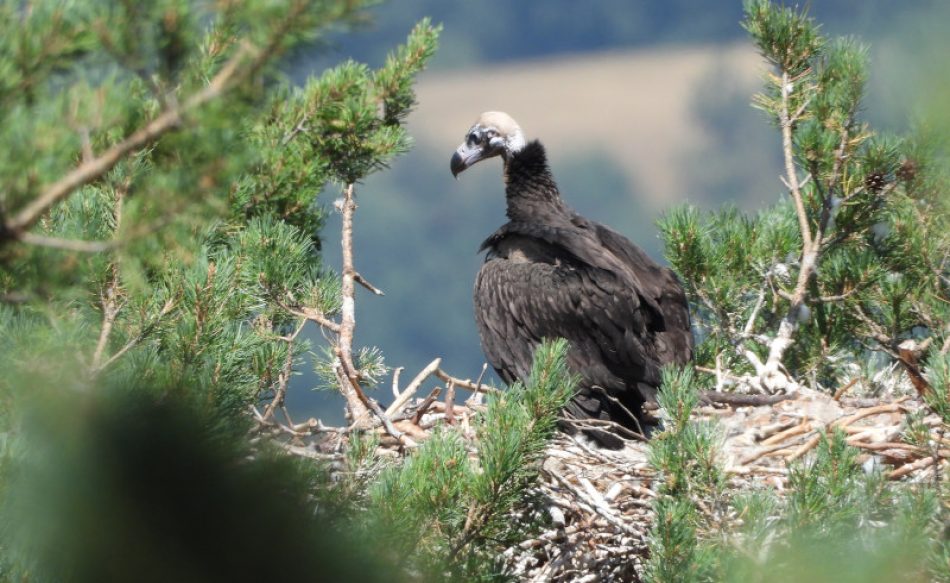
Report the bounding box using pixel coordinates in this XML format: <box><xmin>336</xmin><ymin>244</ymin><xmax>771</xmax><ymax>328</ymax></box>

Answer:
<box><xmin>661</xmin><ymin>0</ymin><xmax>950</xmax><ymax>392</ymax></box>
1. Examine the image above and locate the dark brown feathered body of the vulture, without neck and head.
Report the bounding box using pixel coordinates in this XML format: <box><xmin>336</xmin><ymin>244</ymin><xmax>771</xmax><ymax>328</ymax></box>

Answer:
<box><xmin>475</xmin><ymin>213</ymin><xmax>693</xmax><ymax>436</ymax></box>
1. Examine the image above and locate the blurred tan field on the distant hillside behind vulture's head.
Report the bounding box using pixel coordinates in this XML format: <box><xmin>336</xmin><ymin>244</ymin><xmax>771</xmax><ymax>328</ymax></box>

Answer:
<box><xmin>410</xmin><ymin>44</ymin><xmax>764</xmax><ymax>207</ymax></box>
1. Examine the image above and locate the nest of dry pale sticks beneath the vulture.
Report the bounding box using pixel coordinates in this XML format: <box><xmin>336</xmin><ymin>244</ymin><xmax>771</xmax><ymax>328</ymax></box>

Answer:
<box><xmin>504</xmin><ymin>389</ymin><xmax>950</xmax><ymax>581</ymax></box>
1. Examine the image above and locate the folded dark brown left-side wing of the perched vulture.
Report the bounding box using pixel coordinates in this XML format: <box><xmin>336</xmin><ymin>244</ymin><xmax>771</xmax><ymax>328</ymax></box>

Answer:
<box><xmin>475</xmin><ymin>223</ymin><xmax>660</xmax><ymax>391</ymax></box>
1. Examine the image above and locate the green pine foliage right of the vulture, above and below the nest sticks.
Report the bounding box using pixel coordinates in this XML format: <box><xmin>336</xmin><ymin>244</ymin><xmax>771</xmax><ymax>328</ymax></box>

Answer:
<box><xmin>646</xmin><ymin>0</ymin><xmax>950</xmax><ymax>581</ymax></box>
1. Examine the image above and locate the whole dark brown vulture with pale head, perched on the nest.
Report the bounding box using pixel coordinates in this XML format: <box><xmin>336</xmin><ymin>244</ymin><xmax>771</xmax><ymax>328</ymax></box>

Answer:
<box><xmin>451</xmin><ymin>111</ymin><xmax>693</xmax><ymax>447</ymax></box>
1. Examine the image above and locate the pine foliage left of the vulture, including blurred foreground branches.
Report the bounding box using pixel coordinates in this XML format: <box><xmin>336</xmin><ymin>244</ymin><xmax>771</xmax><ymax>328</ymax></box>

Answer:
<box><xmin>0</xmin><ymin>0</ymin><xmax>572</xmax><ymax>581</ymax></box>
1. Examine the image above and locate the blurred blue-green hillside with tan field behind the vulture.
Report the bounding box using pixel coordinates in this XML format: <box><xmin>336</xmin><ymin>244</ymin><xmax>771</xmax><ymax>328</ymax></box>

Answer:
<box><xmin>288</xmin><ymin>0</ymin><xmax>950</xmax><ymax>421</ymax></box>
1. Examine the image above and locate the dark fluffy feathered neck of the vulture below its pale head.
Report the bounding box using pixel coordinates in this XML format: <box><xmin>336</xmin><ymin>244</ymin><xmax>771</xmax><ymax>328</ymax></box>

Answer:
<box><xmin>505</xmin><ymin>140</ymin><xmax>567</xmax><ymax>221</ymax></box>
